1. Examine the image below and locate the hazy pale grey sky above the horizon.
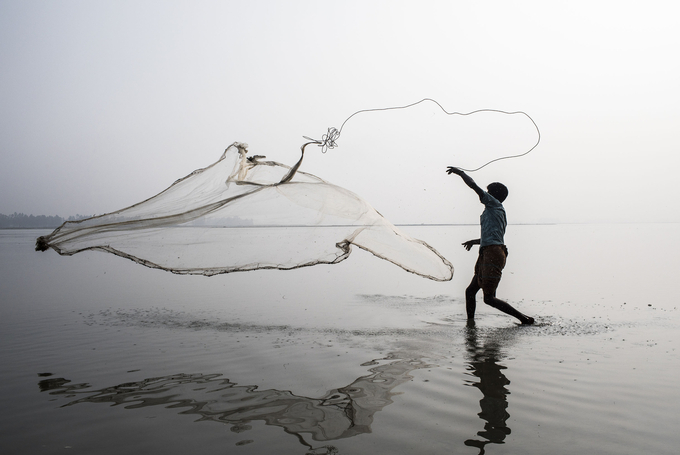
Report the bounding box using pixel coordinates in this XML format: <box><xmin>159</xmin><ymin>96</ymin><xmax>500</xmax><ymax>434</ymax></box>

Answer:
<box><xmin>0</xmin><ymin>0</ymin><xmax>680</xmax><ymax>223</ymax></box>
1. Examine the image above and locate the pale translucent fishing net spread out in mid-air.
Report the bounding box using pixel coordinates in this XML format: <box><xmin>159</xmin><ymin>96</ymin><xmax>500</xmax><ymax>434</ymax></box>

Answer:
<box><xmin>36</xmin><ymin>143</ymin><xmax>453</xmax><ymax>281</ymax></box>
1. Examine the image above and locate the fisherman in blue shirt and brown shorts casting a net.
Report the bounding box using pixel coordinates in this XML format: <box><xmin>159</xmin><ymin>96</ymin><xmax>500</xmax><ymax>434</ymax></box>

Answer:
<box><xmin>446</xmin><ymin>166</ymin><xmax>534</xmax><ymax>324</ymax></box>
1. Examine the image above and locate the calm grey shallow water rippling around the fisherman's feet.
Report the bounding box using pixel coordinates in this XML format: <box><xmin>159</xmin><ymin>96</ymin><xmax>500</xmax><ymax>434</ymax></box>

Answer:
<box><xmin>0</xmin><ymin>224</ymin><xmax>680</xmax><ymax>454</ymax></box>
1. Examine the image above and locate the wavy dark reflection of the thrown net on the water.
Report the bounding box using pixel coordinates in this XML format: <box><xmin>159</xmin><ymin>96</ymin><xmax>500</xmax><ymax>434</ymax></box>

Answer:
<box><xmin>38</xmin><ymin>354</ymin><xmax>427</xmax><ymax>447</ymax></box>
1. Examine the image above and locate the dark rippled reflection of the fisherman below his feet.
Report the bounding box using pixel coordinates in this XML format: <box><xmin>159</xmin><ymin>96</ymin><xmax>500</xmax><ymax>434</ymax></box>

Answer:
<box><xmin>465</xmin><ymin>323</ymin><xmax>510</xmax><ymax>455</ymax></box>
